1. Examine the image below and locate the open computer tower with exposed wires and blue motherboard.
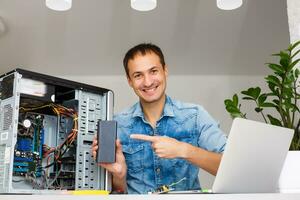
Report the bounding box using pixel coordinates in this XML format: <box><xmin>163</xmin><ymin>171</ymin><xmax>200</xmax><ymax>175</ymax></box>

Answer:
<box><xmin>0</xmin><ymin>69</ymin><xmax>113</xmax><ymax>194</ymax></box>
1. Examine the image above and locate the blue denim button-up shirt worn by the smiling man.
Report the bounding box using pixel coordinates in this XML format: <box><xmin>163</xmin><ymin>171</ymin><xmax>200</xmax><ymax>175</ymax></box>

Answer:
<box><xmin>115</xmin><ymin>96</ymin><xmax>226</xmax><ymax>194</ymax></box>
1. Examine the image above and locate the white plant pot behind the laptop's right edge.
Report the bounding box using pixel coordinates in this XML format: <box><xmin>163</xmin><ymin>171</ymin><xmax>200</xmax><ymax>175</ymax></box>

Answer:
<box><xmin>278</xmin><ymin>151</ymin><xmax>300</xmax><ymax>193</ymax></box>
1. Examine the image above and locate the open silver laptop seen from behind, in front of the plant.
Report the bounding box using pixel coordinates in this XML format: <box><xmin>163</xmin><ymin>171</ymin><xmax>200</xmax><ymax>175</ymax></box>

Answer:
<box><xmin>171</xmin><ymin>118</ymin><xmax>294</xmax><ymax>193</ymax></box>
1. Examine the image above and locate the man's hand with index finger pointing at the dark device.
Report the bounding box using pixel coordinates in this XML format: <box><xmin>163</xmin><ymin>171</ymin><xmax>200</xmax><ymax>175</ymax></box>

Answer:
<box><xmin>130</xmin><ymin>134</ymin><xmax>185</xmax><ymax>158</ymax></box>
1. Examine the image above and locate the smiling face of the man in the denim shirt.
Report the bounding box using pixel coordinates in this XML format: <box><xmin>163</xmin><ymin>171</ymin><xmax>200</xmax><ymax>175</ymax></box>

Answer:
<box><xmin>127</xmin><ymin>52</ymin><xmax>168</xmax><ymax>103</ymax></box>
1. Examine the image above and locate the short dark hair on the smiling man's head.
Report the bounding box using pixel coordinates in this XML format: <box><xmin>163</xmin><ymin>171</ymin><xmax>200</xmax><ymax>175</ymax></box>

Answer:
<box><xmin>123</xmin><ymin>43</ymin><xmax>166</xmax><ymax>77</ymax></box>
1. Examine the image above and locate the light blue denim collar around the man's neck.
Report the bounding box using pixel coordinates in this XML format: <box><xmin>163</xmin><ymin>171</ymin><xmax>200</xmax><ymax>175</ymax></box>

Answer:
<box><xmin>132</xmin><ymin>95</ymin><xmax>175</xmax><ymax>119</ymax></box>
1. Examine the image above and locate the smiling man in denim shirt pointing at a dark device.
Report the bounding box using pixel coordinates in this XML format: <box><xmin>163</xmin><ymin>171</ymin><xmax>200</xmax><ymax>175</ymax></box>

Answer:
<box><xmin>92</xmin><ymin>44</ymin><xmax>226</xmax><ymax>193</ymax></box>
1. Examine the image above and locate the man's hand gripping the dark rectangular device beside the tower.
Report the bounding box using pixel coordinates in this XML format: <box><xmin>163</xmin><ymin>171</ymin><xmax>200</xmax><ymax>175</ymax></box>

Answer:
<box><xmin>92</xmin><ymin>136</ymin><xmax>127</xmax><ymax>179</ymax></box>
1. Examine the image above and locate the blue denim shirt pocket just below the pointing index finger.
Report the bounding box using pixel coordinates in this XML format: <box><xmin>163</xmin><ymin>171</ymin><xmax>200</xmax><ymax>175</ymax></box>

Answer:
<box><xmin>122</xmin><ymin>144</ymin><xmax>144</xmax><ymax>173</ymax></box>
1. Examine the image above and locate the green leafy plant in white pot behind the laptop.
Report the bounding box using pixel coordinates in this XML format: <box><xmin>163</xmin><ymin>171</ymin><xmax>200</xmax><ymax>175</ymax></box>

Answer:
<box><xmin>224</xmin><ymin>41</ymin><xmax>300</xmax><ymax>192</ymax></box>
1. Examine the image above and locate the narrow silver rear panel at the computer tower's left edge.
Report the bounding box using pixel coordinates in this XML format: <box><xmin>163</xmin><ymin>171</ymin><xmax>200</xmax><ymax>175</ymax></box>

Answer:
<box><xmin>0</xmin><ymin>72</ymin><xmax>21</xmax><ymax>193</ymax></box>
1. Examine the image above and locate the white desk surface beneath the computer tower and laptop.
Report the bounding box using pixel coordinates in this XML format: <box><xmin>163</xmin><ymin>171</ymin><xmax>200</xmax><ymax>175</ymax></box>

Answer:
<box><xmin>0</xmin><ymin>193</ymin><xmax>300</xmax><ymax>200</ymax></box>
